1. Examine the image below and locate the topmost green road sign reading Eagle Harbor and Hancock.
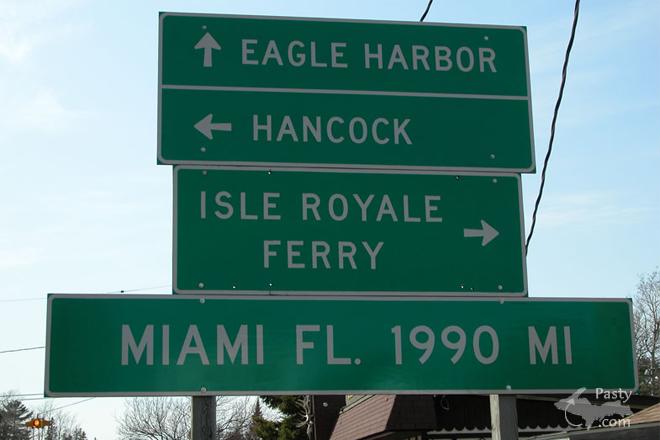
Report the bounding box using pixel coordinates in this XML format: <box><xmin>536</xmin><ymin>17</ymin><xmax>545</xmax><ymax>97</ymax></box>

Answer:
<box><xmin>158</xmin><ymin>13</ymin><xmax>534</xmax><ymax>172</ymax></box>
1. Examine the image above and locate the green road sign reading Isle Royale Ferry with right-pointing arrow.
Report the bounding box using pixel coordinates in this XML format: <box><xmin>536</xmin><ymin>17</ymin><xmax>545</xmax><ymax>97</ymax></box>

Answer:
<box><xmin>173</xmin><ymin>167</ymin><xmax>527</xmax><ymax>295</ymax></box>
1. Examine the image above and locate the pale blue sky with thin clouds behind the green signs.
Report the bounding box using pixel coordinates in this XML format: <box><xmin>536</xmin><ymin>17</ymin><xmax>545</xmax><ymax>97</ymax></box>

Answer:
<box><xmin>0</xmin><ymin>0</ymin><xmax>660</xmax><ymax>440</ymax></box>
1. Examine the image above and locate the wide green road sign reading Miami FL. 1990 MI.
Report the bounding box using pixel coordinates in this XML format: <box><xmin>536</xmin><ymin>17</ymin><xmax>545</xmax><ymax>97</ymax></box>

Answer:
<box><xmin>45</xmin><ymin>295</ymin><xmax>637</xmax><ymax>396</ymax></box>
